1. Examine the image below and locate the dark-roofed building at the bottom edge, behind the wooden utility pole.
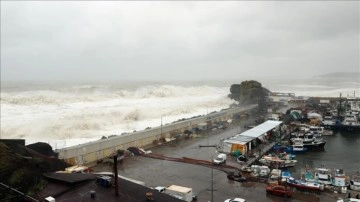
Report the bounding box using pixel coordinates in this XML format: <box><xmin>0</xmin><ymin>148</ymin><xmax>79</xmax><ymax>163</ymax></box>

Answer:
<box><xmin>37</xmin><ymin>173</ymin><xmax>183</xmax><ymax>202</ymax></box>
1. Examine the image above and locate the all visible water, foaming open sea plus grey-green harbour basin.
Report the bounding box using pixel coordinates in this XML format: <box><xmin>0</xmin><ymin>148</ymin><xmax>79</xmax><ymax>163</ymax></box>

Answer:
<box><xmin>1</xmin><ymin>79</ymin><xmax>360</xmax><ymax>170</ymax></box>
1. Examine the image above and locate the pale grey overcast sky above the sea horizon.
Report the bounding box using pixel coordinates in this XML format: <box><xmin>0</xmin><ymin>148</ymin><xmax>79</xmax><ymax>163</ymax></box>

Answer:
<box><xmin>1</xmin><ymin>1</ymin><xmax>360</xmax><ymax>80</ymax></box>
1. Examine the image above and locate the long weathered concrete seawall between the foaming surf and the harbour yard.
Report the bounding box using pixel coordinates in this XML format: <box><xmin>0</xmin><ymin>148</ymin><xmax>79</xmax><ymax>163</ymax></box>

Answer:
<box><xmin>59</xmin><ymin>105</ymin><xmax>257</xmax><ymax>165</ymax></box>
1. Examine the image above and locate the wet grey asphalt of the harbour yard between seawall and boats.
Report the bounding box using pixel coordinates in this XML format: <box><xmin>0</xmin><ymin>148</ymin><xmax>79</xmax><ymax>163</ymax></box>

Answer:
<box><xmin>94</xmin><ymin>118</ymin><xmax>352</xmax><ymax>202</ymax></box>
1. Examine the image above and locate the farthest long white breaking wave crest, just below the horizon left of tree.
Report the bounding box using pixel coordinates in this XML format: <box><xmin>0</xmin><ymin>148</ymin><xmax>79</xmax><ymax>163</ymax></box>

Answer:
<box><xmin>1</xmin><ymin>85</ymin><xmax>228</xmax><ymax>105</ymax></box>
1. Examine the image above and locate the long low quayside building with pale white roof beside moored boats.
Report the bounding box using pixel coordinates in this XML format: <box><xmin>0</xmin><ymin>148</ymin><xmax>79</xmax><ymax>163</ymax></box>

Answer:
<box><xmin>222</xmin><ymin>120</ymin><xmax>282</xmax><ymax>153</ymax></box>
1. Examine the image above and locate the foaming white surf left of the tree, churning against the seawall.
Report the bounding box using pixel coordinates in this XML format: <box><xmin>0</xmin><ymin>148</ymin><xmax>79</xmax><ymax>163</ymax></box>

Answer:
<box><xmin>1</xmin><ymin>82</ymin><xmax>233</xmax><ymax>147</ymax></box>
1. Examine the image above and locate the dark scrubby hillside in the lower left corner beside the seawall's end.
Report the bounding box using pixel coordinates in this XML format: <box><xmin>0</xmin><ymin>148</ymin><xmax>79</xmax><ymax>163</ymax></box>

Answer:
<box><xmin>0</xmin><ymin>142</ymin><xmax>68</xmax><ymax>199</ymax></box>
